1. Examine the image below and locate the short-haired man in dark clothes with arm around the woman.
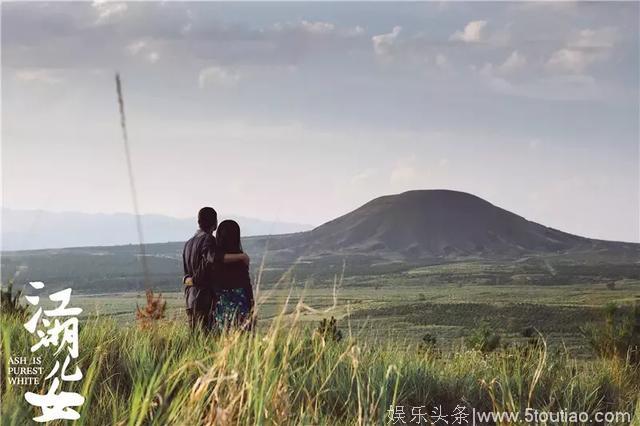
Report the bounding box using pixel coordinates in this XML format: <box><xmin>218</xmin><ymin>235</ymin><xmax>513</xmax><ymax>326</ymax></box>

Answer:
<box><xmin>182</xmin><ymin>207</ymin><xmax>249</xmax><ymax>330</ymax></box>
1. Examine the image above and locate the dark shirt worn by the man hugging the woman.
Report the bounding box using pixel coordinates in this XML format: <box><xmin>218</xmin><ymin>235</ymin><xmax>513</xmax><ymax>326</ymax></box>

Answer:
<box><xmin>182</xmin><ymin>229</ymin><xmax>224</xmax><ymax>290</ymax></box>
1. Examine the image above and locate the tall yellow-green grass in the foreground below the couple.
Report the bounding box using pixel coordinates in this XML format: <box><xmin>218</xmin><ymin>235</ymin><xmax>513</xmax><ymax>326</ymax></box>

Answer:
<box><xmin>1</xmin><ymin>310</ymin><xmax>640</xmax><ymax>425</ymax></box>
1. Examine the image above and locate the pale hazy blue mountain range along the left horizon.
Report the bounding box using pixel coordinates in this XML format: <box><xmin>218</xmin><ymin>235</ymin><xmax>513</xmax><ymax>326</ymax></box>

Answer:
<box><xmin>1</xmin><ymin>208</ymin><xmax>312</xmax><ymax>250</ymax></box>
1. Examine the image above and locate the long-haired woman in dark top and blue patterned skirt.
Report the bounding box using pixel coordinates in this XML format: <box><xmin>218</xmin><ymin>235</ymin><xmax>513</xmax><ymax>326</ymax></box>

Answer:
<box><xmin>211</xmin><ymin>220</ymin><xmax>254</xmax><ymax>331</ymax></box>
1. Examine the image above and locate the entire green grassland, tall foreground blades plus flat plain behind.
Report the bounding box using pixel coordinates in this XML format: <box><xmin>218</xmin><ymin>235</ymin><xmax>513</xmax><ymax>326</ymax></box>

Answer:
<box><xmin>2</xmin><ymin>263</ymin><xmax>640</xmax><ymax>425</ymax></box>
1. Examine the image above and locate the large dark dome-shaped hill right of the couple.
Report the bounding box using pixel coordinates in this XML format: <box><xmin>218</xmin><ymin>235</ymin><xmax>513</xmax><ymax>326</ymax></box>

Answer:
<box><xmin>271</xmin><ymin>190</ymin><xmax>637</xmax><ymax>258</ymax></box>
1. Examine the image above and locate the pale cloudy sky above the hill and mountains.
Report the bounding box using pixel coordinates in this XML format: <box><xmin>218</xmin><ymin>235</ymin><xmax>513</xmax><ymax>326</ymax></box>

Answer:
<box><xmin>2</xmin><ymin>2</ymin><xmax>640</xmax><ymax>241</ymax></box>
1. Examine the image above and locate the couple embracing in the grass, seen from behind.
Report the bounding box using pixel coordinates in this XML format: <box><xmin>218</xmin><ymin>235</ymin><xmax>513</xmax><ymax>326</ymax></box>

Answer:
<box><xmin>182</xmin><ymin>207</ymin><xmax>254</xmax><ymax>331</ymax></box>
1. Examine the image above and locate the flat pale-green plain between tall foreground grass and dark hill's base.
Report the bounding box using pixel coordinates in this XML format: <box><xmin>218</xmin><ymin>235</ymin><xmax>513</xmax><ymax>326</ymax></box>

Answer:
<box><xmin>61</xmin><ymin>272</ymin><xmax>640</xmax><ymax>357</ymax></box>
